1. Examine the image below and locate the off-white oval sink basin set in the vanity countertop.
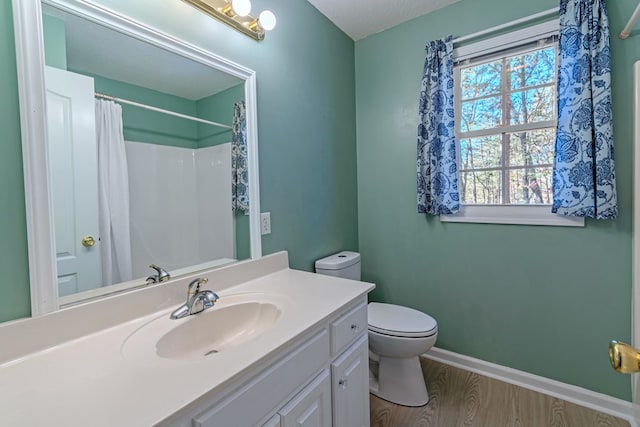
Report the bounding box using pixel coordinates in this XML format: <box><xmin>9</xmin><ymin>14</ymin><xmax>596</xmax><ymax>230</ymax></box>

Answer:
<box><xmin>122</xmin><ymin>293</ymin><xmax>285</xmax><ymax>361</ymax></box>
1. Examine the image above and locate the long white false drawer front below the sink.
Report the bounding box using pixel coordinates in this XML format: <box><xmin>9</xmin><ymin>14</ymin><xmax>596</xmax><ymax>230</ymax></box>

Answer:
<box><xmin>193</xmin><ymin>329</ymin><xmax>329</xmax><ymax>427</ymax></box>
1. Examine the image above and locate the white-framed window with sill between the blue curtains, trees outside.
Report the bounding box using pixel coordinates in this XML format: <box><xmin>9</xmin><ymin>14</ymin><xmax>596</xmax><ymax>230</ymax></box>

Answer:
<box><xmin>441</xmin><ymin>21</ymin><xmax>584</xmax><ymax>225</ymax></box>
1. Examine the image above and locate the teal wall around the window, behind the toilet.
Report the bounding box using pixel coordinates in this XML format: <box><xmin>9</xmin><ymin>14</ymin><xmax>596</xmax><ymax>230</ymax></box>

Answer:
<box><xmin>355</xmin><ymin>0</ymin><xmax>640</xmax><ymax>399</ymax></box>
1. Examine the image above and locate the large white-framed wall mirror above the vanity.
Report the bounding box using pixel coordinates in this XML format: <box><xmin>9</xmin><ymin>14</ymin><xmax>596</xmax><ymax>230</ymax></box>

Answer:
<box><xmin>13</xmin><ymin>0</ymin><xmax>261</xmax><ymax>315</ymax></box>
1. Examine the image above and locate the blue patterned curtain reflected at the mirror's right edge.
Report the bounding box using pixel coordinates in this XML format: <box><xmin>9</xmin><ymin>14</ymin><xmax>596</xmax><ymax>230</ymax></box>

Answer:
<box><xmin>231</xmin><ymin>101</ymin><xmax>249</xmax><ymax>213</ymax></box>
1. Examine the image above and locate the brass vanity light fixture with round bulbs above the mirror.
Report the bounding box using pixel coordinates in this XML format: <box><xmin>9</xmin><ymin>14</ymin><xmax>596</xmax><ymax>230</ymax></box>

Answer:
<box><xmin>183</xmin><ymin>0</ymin><xmax>276</xmax><ymax>41</ymax></box>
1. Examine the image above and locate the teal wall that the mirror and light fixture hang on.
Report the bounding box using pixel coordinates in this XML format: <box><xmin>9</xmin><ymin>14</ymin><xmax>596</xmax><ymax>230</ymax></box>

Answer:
<box><xmin>0</xmin><ymin>0</ymin><xmax>358</xmax><ymax>320</ymax></box>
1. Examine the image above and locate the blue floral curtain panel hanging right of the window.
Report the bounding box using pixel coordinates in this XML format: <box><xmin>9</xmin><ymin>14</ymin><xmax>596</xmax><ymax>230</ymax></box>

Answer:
<box><xmin>552</xmin><ymin>0</ymin><xmax>618</xmax><ymax>219</ymax></box>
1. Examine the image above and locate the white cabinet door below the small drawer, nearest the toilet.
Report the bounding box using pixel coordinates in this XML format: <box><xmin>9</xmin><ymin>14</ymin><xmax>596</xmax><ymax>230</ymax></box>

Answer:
<box><xmin>331</xmin><ymin>335</ymin><xmax>369</xmax><ymax>427</ymax></box>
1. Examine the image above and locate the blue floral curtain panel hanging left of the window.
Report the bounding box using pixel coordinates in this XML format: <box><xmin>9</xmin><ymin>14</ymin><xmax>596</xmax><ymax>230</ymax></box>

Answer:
<box><xmin>418</xmin><ymin>36</ymin><xmax>460</xmax><ymax>215</ymax></box>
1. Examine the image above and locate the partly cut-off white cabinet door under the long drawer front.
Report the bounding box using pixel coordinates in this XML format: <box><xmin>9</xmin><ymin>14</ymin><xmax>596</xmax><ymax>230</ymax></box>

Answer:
<box><xmin>278</xmin><ymin>369</ymin><xmax>331</xmax><ymax>427</ymax></box>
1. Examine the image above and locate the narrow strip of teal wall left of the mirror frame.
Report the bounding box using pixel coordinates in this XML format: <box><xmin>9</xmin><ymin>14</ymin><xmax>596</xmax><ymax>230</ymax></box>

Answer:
<box><xmin>0</xmin><ymin>1</ymin><xmax>31</xmax><ymax>322</ymax></box>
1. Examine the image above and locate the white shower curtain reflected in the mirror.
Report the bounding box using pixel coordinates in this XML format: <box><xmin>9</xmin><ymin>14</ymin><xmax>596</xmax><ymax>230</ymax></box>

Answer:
<box><xmin>96</xmin><ymin>100</ymin><xmax>133</xmax><ymax>285</ymax></box>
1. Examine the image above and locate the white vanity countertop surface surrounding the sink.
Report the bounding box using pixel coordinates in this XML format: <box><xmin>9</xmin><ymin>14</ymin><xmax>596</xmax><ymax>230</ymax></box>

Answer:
<box><xmin>0</xmin><ymin>254</ymin><xmax>373</xmax><ymax>427</ymax></box>
